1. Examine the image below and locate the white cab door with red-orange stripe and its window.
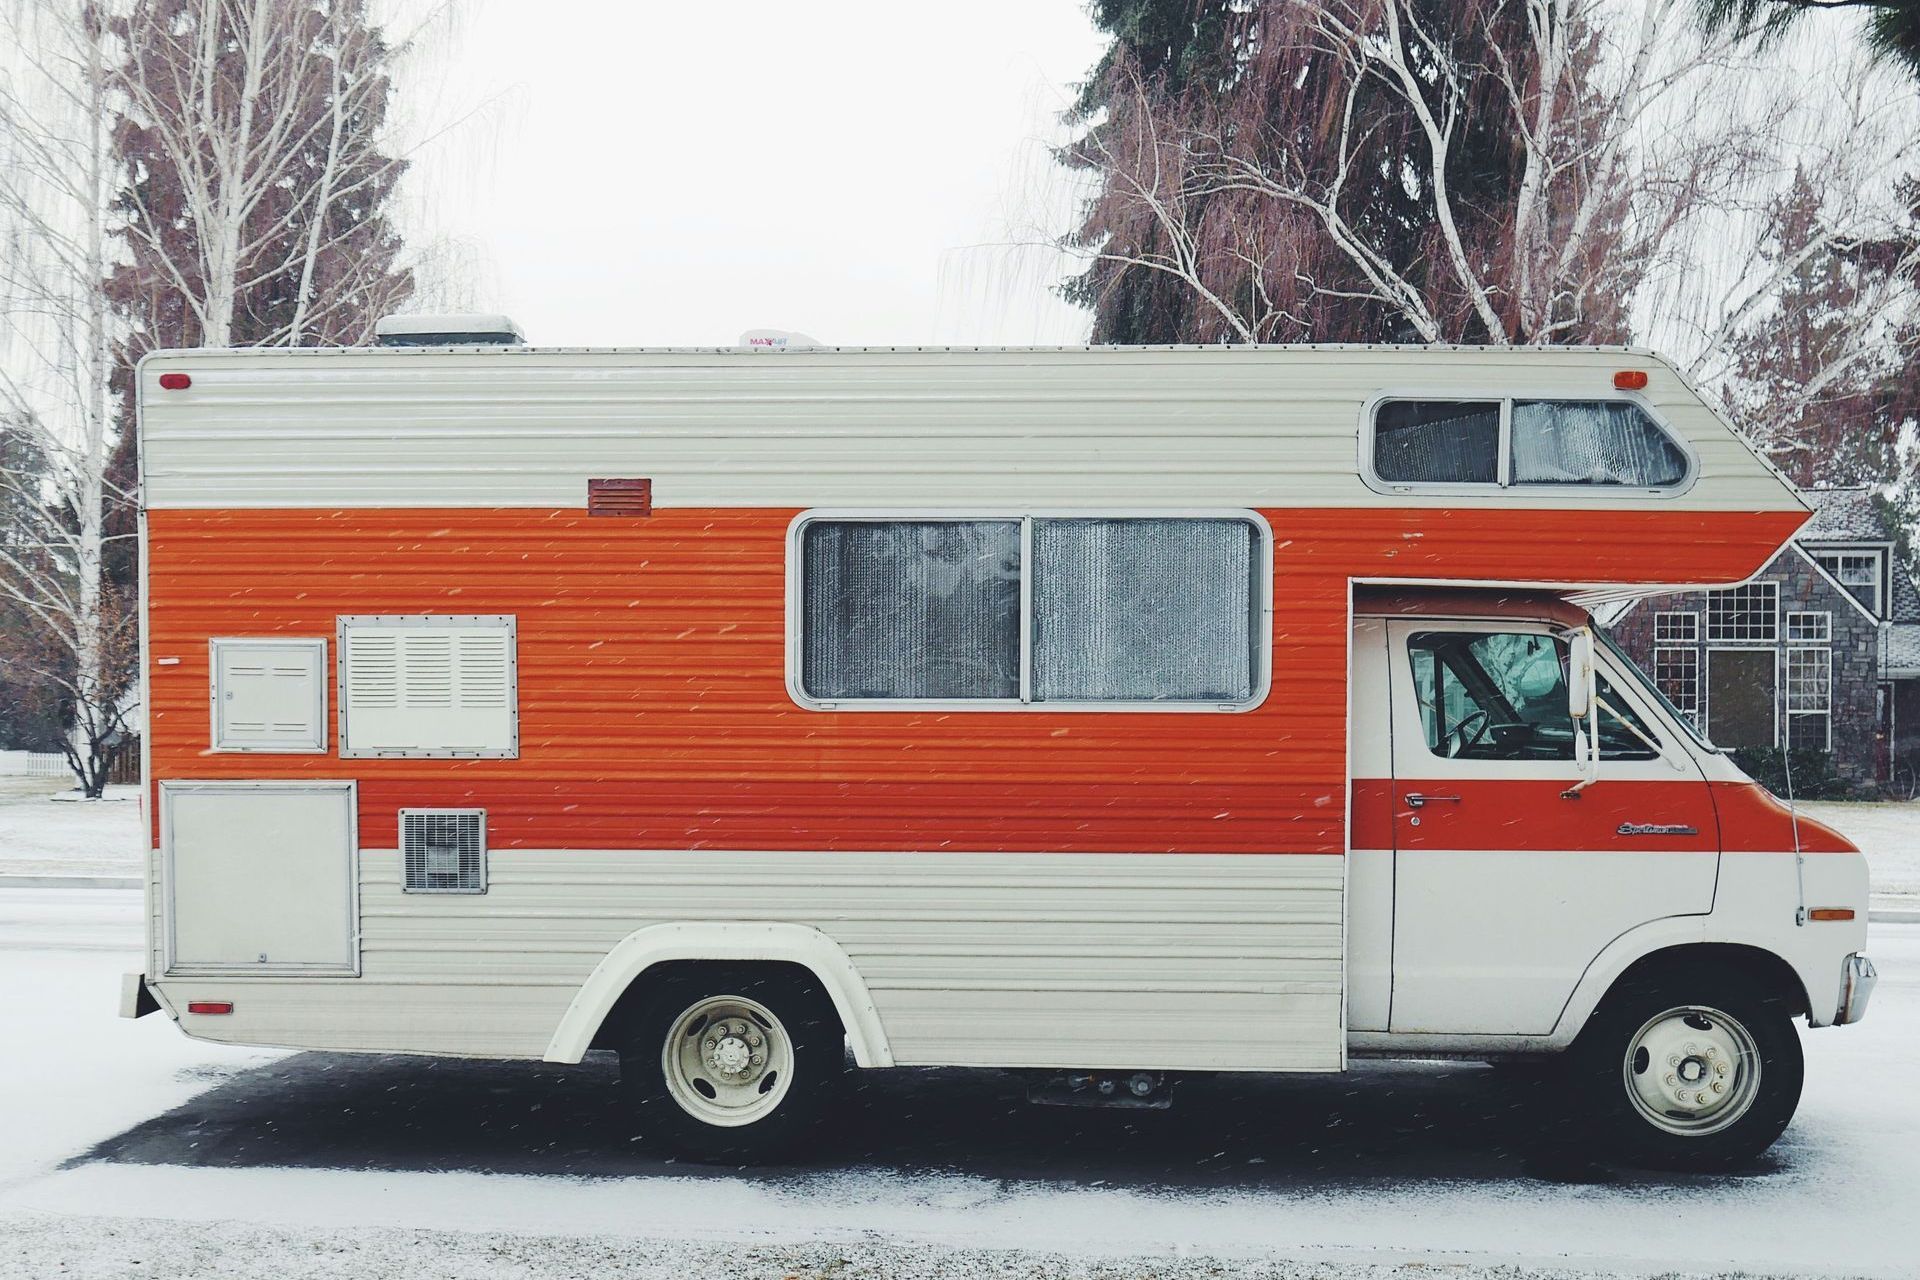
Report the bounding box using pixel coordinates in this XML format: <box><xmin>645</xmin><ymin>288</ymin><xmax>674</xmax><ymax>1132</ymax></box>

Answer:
<box><xmin>1388</xmin><ymin>620</ymin><xmax>1718</xmax><ymax>1034</ymax></box>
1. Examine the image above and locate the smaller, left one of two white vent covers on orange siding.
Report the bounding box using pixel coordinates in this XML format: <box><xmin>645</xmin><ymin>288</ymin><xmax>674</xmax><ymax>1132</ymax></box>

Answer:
<box><xmin>207</xmin><ymin>635</ymin><xmax>326</xmax><ymax>754</ymax></box>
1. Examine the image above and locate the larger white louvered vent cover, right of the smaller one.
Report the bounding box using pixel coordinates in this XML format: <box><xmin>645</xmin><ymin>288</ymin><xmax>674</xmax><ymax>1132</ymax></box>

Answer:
<box><xmin>340</xmin><ymin>614</ymin><xmax>520</xmax><ymax>756</ymax></box>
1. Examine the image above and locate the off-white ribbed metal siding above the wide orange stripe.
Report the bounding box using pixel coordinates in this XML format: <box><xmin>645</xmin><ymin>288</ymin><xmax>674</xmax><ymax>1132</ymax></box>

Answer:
<box><xmin>140</xmin><ymin>347</ymin><xmax>1805</xmax><ymax>514</ymax></box>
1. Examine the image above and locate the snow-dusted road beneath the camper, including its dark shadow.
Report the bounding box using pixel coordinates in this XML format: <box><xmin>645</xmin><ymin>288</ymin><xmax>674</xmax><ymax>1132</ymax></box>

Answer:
<box><xmin>0</xmin><ymin>889</ymin><xmax>1920</xmax><ymax>1280</ymax></box>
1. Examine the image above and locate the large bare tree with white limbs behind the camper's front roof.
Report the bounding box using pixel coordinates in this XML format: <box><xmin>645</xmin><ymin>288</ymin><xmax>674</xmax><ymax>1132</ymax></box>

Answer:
<box><xmin>1077</xmin><ymin>0</ymin><xmax>1763</xmax><ymax>344</ymax></box>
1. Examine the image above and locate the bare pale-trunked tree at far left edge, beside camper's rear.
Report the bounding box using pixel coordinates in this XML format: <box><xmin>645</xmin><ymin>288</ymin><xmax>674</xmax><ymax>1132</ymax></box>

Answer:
<box><xmin>0</xmin><ymin>6</ymin><xmax>136</xmax><ymax>796</ymax></box>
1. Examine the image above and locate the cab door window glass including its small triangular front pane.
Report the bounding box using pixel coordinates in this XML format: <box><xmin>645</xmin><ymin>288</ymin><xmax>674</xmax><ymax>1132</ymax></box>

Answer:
<box><xmin>1407</xmin><ymin>631</ymin><xmax>1659</xmax><ymax>760</ymax></box>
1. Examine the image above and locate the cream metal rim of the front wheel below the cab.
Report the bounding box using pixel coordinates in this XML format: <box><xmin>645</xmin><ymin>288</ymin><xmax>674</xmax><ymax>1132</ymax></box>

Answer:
<box><xmin>1622</xmin><ymin>1006</ymin><xmax>1761</xmax><ymax>1138</ymax></box>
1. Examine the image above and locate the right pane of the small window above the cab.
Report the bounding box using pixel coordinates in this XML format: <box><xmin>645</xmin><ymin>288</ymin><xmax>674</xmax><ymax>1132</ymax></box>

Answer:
<box><xmin>1513</xmin><ymin>399</ymin><xmax>1686</xmax><ymax>489</ymax></box>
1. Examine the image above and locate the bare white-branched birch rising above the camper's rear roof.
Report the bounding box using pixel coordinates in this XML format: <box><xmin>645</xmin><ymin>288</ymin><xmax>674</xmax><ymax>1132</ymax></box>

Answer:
<box><xmin>111</xmin><ymin>0</ymin><xmax>413</xmax><ymax>347</ymax></box>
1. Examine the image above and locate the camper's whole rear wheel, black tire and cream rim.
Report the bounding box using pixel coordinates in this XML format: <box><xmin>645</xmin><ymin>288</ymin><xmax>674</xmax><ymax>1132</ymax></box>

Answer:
<box><xmin>620</xmin><ymin>965</ymin><xmax>845</xmax><ymax>1161</ymax></box>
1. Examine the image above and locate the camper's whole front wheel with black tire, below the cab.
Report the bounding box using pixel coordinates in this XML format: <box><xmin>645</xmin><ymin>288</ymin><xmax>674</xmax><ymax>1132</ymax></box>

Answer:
<box><xmin>1561</xmin><ymin>965</ymin><xmax>1805</xmax><ymax>1173</ymax></box>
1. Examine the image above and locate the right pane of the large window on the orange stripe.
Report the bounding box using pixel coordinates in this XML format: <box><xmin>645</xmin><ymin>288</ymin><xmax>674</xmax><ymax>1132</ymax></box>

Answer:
<box><xmin>1033</xmin><ymin>520</ymin><xmax>1256</xmax><ymax>702</ymax></box>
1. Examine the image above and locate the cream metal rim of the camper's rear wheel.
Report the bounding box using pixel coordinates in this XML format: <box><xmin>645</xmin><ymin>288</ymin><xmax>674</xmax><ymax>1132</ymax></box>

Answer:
<box><xmin>660</xmin><ymin>996</ymin><xmax>793</xmax><ymax>1128</ymax></box>
